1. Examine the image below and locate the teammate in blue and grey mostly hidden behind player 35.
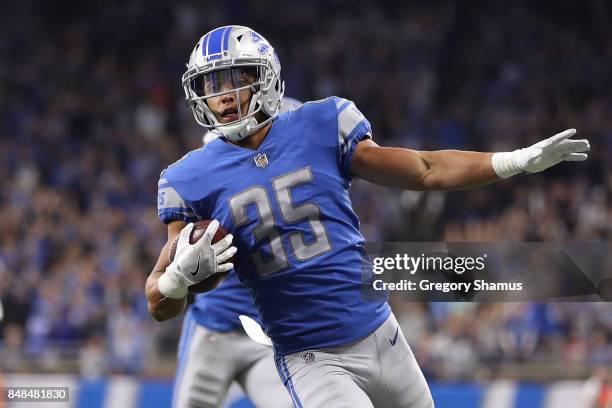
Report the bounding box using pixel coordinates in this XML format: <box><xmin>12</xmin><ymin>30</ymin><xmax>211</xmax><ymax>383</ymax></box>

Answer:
<box><xmin>164</xmin><ymin>98</ymin><xmax>301</xmax><ymax>408</ymax></box>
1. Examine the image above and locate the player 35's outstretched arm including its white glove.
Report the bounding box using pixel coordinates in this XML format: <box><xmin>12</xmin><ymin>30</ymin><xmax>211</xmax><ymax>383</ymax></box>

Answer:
<box><xmin>351</xmin><ymin>129</ymin><xmax>590</xmax><ymax>190</ymax></box>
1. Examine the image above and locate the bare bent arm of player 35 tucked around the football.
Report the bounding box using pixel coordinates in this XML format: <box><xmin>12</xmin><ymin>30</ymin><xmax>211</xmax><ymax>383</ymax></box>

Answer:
<box><xmin>145</xmin><ymin>221</ymin><xmax>187</xmax><ymax>322</ymax></box>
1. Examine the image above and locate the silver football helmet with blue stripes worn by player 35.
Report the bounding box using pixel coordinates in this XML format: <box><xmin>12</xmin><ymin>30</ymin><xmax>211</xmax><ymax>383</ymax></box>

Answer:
<box><xmin>182</xmin><ymin>26</ymin><xmax>285</xmax><ymax>142</ymax></box>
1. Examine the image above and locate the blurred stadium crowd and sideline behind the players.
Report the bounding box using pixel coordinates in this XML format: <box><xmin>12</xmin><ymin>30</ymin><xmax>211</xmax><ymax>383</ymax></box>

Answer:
<box><xmin>0</xmin><ymin>0</ymin><xmax>612</xmax><ymax>407</ymax></box>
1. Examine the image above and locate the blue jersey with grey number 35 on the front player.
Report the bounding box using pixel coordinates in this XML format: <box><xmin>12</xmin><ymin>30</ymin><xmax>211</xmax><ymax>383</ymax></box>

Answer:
<box><xmin>160</xmin><ymin>97</ymin><xmax>390</xmax><ymax>354</ymax></box>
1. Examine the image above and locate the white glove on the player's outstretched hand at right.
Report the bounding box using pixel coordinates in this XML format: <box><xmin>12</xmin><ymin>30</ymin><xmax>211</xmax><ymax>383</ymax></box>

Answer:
<box><xmin>491</xmin><ymin>129</ymin><xmax>591</xmax><ymax>178</ymax></box>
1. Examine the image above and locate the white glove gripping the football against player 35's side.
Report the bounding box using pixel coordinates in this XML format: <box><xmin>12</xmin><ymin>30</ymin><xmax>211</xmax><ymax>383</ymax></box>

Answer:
<box><xmin>157</xmin><ymin>220</ymin><xmax>237</xmax><ymax>299</ymax></box>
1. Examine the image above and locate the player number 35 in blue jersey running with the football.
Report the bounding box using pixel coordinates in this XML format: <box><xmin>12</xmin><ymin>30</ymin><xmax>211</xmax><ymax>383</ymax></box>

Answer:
<box><xmin>146</xmin><ymin>26</ymin><xmax>589</xmax><ymax>408</ymax></box>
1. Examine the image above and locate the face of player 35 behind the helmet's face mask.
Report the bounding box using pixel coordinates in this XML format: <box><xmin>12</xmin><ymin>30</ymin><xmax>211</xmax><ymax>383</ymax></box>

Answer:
<box><xmin>203</xmin><ymin>67</ymin><xmax>257</xmax><ymax>123</ymax></box>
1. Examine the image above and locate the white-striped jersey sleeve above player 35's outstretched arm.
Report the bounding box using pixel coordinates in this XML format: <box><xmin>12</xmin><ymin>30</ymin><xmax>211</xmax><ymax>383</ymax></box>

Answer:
<box><xmin>336</xmin><ymin>98</ymin><xmax>372</xmax><ymax>180</ymax></box>
